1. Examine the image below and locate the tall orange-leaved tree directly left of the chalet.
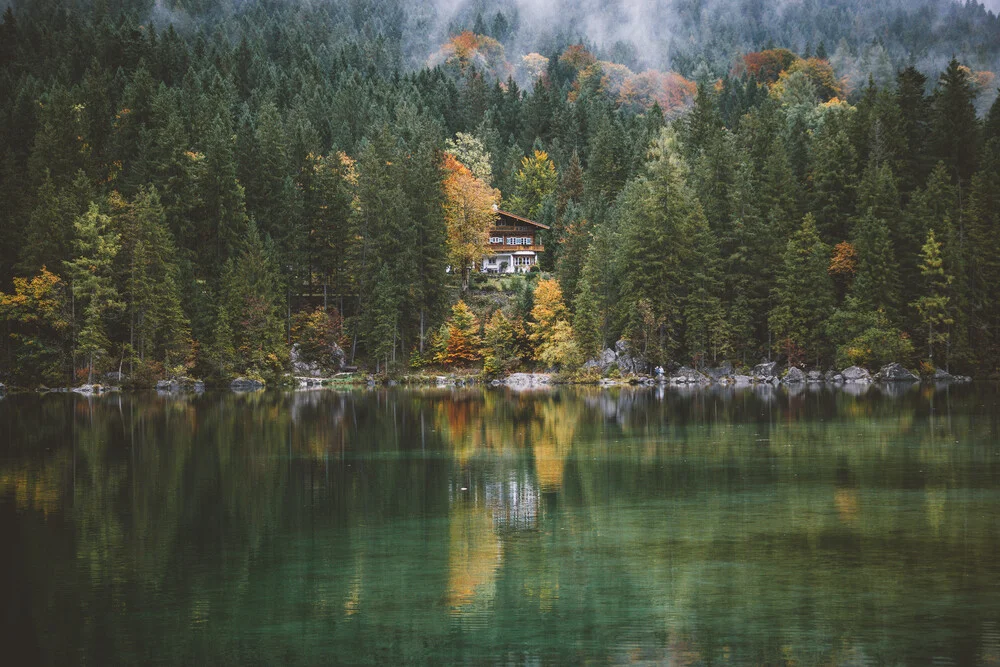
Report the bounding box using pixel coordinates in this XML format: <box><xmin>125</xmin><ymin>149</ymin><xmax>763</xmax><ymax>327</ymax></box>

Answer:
<box><xmin>444</xmin><ymin>153</ymin><xmax>500</xmax><ymax>292</ymax></box>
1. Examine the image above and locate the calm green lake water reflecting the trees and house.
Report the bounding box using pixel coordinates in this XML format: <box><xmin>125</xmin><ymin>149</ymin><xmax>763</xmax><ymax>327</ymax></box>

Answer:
<box><xmin>0</xmin><ymin>385</ymin><xmax>1000</xmax><ymax>665</ymax></box>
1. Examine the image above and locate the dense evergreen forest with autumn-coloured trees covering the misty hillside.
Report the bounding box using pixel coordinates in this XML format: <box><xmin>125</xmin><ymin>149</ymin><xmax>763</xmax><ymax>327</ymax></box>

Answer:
<box><xmin>0</xmin><ymin>0</ymin><xmax>1000</xmax><ymax>387</ymax></box>
